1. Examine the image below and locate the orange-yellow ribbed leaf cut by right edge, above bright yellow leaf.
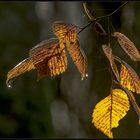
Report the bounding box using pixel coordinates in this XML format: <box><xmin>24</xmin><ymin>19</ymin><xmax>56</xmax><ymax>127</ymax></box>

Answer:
<box><xmin>120</xmin><ymin>63</ymin><xmax>140</xmax><ymax>93</ymax></box>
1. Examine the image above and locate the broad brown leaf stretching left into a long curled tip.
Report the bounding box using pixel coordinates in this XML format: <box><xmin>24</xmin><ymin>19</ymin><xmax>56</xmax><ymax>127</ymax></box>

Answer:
<box><xmin>7</xmin><ymin>38</ymin><xmax>67</xmax><ymax>85</ymax></box>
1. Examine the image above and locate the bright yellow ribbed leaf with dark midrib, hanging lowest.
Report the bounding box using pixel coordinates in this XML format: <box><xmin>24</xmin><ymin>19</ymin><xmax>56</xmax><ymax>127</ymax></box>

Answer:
<box><xmin>92</xmin><ymin>89</ymin><xmax>130</xmax><ymax>138</ymax></box>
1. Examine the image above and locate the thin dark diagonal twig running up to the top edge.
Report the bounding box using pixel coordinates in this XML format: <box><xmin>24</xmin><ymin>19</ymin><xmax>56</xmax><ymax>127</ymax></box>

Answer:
<box><xmin>78</xmin><ymin>1</ymin><xmax>128</xmax><ymax>34</ymax></box>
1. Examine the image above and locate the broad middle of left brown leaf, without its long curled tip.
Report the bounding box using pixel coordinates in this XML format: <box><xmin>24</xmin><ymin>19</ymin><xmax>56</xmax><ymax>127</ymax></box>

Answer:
<box><xmin>30</xmin><ymin>39</ymin><xmax>67</xmax><ymax>80</ymax></box>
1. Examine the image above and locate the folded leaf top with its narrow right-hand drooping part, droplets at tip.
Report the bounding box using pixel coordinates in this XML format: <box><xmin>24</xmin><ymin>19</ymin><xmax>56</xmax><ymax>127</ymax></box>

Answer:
<box><xmin>53</xmin><ymin>22</ymin><xmax>88</xmax><ymax>80</ymax></box>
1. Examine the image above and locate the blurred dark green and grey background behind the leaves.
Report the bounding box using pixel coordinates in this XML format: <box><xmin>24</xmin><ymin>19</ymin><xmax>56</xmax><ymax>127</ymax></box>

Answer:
<box><xmin>0</xmin><ymin>1</ymin><xmax>140</xmax><ymax>138</ymax></box>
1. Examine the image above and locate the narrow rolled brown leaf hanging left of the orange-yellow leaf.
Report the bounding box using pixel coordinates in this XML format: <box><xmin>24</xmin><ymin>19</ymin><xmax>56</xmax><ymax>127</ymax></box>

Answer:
<box><xmin>102</xmin><ymin>45</ymin><xmax>120</xmax><ymax>81</ymax></box>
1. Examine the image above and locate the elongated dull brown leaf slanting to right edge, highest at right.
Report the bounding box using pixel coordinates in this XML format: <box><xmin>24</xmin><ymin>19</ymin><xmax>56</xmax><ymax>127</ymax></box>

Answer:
<box><xmin>113</xmin><ymin>32</ymin><xmax>140</xmax><ymax>61</ymax></box>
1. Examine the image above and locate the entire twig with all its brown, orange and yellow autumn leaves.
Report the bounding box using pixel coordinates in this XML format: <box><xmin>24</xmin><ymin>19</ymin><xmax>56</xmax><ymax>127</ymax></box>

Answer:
<box><xmin>6</xmin><ymin>2</ymin><xmax>140</xmax><ymax>138</ymax></box>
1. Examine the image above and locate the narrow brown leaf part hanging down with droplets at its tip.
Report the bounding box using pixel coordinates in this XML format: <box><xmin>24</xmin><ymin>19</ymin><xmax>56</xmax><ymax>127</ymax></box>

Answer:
<box><xmin>67</xmin><ymin>40</ymin><xmax>88</xmax><ymax>80</ymax></box>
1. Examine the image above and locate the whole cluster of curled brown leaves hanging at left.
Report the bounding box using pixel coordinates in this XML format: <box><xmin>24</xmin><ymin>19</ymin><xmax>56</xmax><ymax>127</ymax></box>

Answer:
<box><xmin>6</xmin><ymin>22</ymin><xmax>88</xmax><ymax>86</ymax></box>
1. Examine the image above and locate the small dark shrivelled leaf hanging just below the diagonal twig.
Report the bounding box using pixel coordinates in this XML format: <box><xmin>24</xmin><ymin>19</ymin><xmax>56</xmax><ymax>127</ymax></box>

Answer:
<box><xmin>94</xmin><ymin>22</ymin><xmax>107</xmax><ymax>35</ymax></box>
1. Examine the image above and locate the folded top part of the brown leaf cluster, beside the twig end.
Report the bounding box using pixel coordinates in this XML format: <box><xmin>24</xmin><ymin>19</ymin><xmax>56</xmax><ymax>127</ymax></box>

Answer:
<box><xmin>52</xmin><ymin>21</ymin><xmax>80</xmax><ymax>43</ymax></box>
